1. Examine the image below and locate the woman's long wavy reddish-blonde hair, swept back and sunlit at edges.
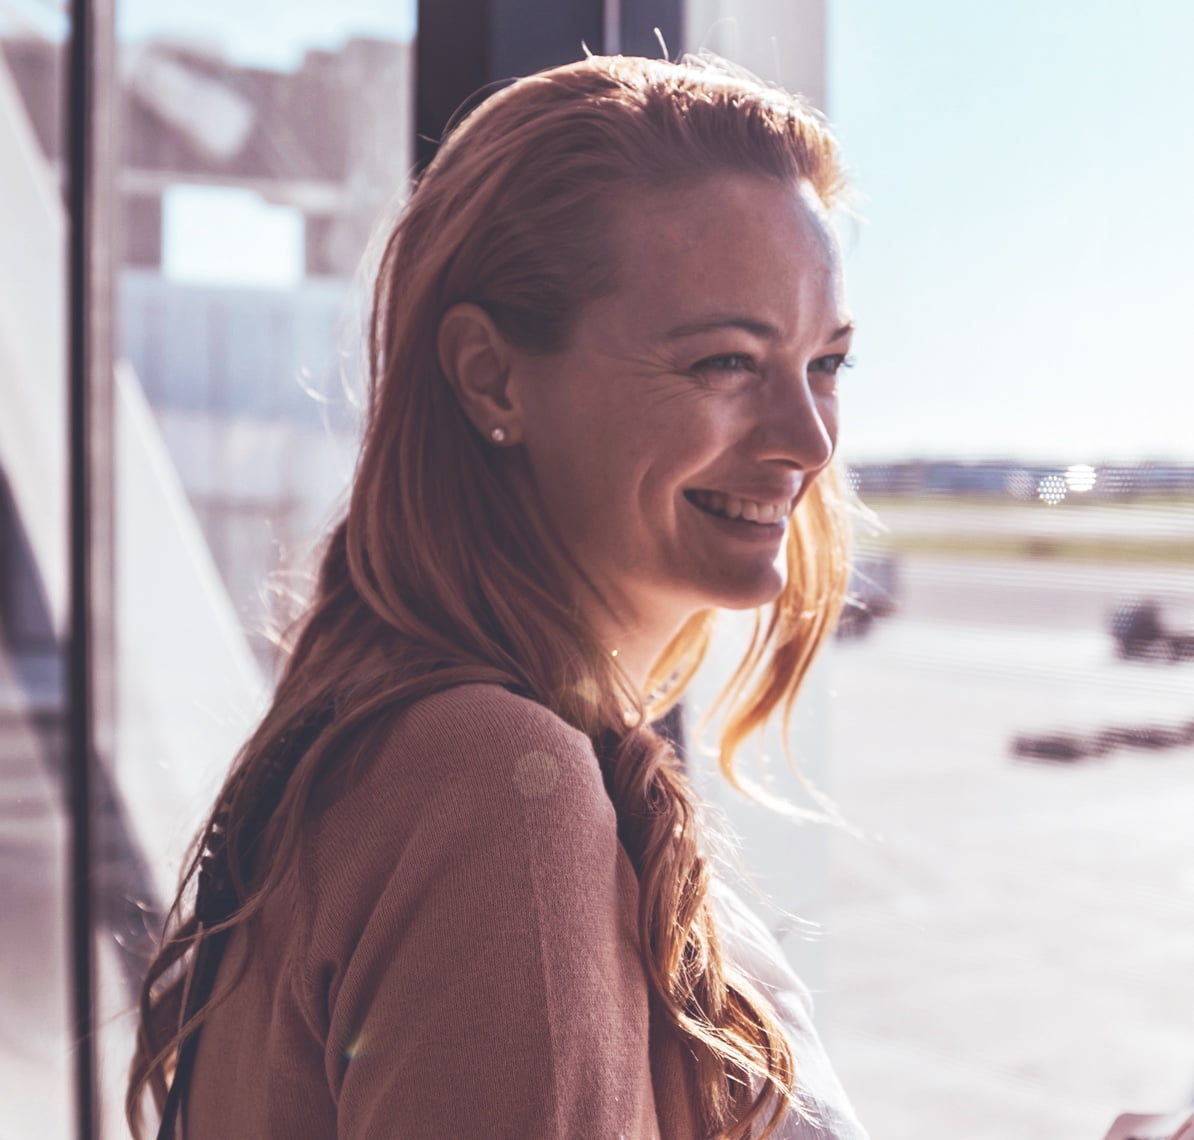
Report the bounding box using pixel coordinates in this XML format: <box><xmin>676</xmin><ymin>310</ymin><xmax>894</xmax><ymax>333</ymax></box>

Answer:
<box><xmin>127</xmin><ymin>57</ymin><xmax>848</xmax><ymax>1138</ymax></box>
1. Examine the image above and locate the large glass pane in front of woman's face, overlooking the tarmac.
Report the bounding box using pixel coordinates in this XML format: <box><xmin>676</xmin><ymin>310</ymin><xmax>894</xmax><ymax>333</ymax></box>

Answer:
<box><xmin>687</xmin><ymin>0</ymin><xmax>1194</xmax><ymax>1140</ymax></box>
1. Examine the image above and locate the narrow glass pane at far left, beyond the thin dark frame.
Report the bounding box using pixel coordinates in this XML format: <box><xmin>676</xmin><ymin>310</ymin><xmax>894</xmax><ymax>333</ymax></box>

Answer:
<box><xmin>0</xmin><ymin>5</ymin><xmax>74</xmax><ymax>1140</ymax></box>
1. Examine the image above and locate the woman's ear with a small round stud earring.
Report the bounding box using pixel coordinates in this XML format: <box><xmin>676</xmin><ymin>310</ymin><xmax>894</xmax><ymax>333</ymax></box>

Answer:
<box><xmin>436</xmin><ymin>302</ymin><xmax>522</xmax><ymax>445</ymax></box>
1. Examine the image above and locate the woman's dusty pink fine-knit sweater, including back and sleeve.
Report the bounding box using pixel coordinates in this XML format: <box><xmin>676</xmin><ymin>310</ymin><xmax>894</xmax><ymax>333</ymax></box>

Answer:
<box><xmin>186</xmin><ymin>685</ymin><xmax>861</xmax><ymax>1140</ymax></box>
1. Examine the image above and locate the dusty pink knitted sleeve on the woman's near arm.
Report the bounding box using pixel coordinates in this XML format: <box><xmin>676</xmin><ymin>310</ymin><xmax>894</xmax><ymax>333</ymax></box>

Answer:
<box><xmin>303</xmin><ymin>685</ymin><xmax>658</xmax><ymax>1140</ymax></box>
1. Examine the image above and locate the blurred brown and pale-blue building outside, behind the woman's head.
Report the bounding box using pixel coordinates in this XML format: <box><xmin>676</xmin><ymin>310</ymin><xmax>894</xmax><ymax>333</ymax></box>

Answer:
<box><xmin>0</xmin><ymin>38</ymin><xmax>414</xmax><ymax>661</ymax></box>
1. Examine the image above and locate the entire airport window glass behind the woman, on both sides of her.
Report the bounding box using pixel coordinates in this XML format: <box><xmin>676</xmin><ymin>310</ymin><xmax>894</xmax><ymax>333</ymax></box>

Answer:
<box><xmin>0</xmin><ymin>0</ymin><xmax>1194</xmax><ymax>1140</ymax></box>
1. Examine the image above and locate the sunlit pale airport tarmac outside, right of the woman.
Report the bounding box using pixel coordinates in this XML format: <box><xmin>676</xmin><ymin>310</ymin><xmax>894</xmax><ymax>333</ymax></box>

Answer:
<box><xmin>818</xmin><ymin>557</ymin><xmax>1194</xmax><ymax>1140</ymax></box>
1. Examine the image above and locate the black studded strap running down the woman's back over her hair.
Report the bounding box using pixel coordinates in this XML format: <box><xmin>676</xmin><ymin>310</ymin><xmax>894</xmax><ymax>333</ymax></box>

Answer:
<box><xmin>158</xmin><ymin>708</ymin><xmax>334</xmax><ymax>1140</ymax></box>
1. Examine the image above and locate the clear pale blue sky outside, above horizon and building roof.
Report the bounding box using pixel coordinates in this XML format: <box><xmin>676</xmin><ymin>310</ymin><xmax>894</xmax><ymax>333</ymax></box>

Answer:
<box><xmin>34</xmin><ymin>0</ymin><xmax>1194</xmax><ymax>462</ymax></box>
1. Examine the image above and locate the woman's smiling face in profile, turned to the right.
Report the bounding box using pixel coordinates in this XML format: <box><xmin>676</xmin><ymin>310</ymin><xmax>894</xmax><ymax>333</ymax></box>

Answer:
<box><xmin>518</xmin><ymin>174</ymin><xmax>850</xmax><ymax>629</ymax></box>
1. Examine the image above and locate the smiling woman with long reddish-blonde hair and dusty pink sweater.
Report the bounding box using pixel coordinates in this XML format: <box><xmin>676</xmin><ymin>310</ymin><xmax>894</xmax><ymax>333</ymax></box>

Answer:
<box><xmin>129</xmin><ymin>57</ymin><xmax>862</xmax><ymax>1140</ymax></box>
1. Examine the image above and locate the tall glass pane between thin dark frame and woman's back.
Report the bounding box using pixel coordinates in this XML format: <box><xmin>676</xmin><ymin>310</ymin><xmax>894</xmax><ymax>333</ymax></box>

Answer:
<box><xmin>101</xmin><ymin>0</ymin><xmax>413</xmax><ymax>1135</ymax></box>
